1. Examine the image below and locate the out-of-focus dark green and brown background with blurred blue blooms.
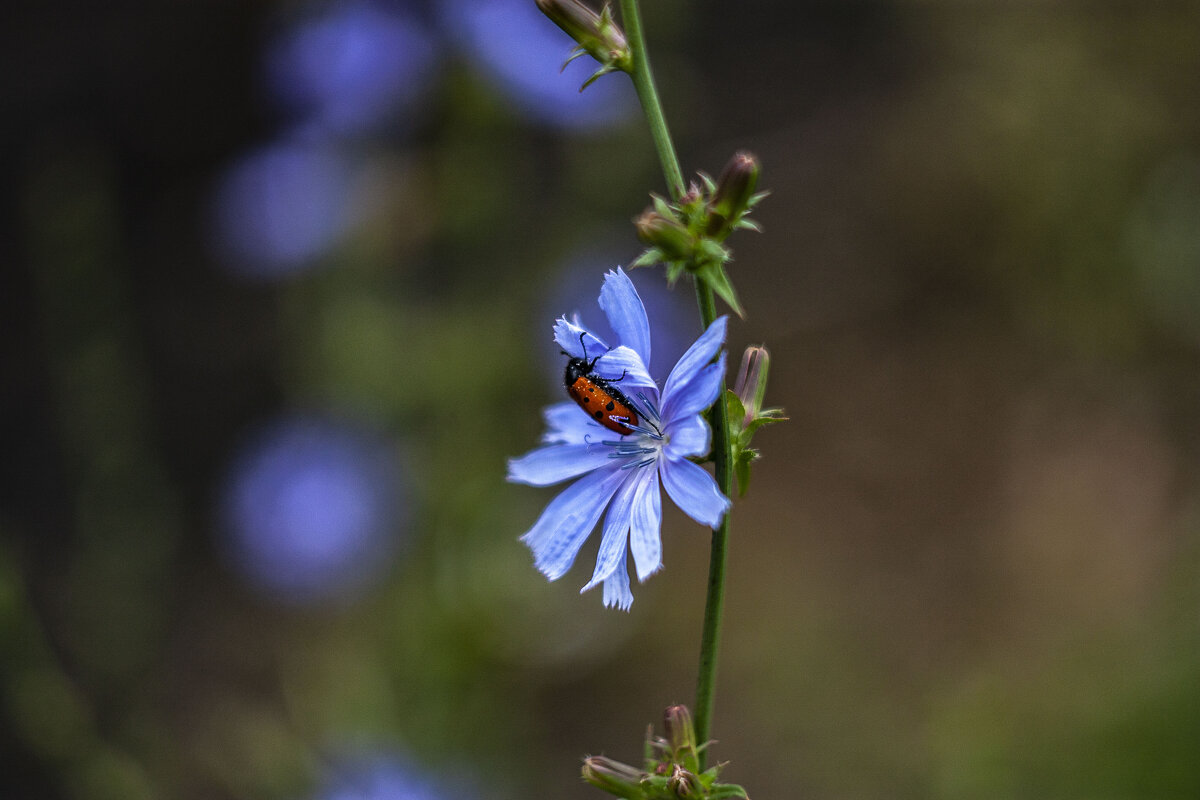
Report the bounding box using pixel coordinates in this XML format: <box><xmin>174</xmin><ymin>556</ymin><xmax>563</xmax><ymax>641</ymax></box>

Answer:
<box><xmin>0</xmin><ymin>0</ymin><xmax>1200</xmax><ymax>800</ymax></box>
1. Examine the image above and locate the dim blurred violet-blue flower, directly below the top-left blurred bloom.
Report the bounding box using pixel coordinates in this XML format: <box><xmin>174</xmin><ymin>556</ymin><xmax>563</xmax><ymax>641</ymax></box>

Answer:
<box><xmin>214</xmin><ymin>142</ymin><xmax>362</xmax><ymax>278</ymax></box>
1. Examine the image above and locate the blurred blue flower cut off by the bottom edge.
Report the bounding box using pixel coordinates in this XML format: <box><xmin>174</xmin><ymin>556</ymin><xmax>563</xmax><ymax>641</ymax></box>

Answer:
<box><xmin>316</xmin><ymin>756</ymin><xmax>475</xmax><ymax>800</ymax></box>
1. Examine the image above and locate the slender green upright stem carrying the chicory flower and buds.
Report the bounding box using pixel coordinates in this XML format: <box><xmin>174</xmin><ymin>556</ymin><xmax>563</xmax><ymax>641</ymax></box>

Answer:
<box><xmin>620</xmin><ymin>0</ymin><xmax>733</xmax><ymax>769</ymax></box>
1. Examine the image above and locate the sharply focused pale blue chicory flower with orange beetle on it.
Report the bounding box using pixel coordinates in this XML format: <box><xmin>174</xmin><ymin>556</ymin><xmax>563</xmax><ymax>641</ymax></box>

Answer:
<box><xmin>509</xmin><ymin>267</ymin><xmax>730</xmax><ymax>610</ymax></box>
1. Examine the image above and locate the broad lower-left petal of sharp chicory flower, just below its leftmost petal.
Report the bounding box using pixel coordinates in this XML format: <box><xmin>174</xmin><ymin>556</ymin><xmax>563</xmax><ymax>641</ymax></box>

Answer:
<box><xmin>521</xmin><ymin>465</ymin><xmax>626</xmax><ymax>581</ymax></box>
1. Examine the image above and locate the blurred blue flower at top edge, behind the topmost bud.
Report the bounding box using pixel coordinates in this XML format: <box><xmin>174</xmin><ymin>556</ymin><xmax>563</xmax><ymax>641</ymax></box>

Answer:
<box><xmin>440</xmin><ymin>0</ymin><xmax>637</xmax><ymax>128</ymax></box>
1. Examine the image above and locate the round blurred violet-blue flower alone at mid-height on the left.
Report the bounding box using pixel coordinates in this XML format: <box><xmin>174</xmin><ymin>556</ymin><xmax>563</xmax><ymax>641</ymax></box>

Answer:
<box><xmin>222</xmin><ymin>417</ymin><xmax>403</xmax><ymax>603</ymax></box>
